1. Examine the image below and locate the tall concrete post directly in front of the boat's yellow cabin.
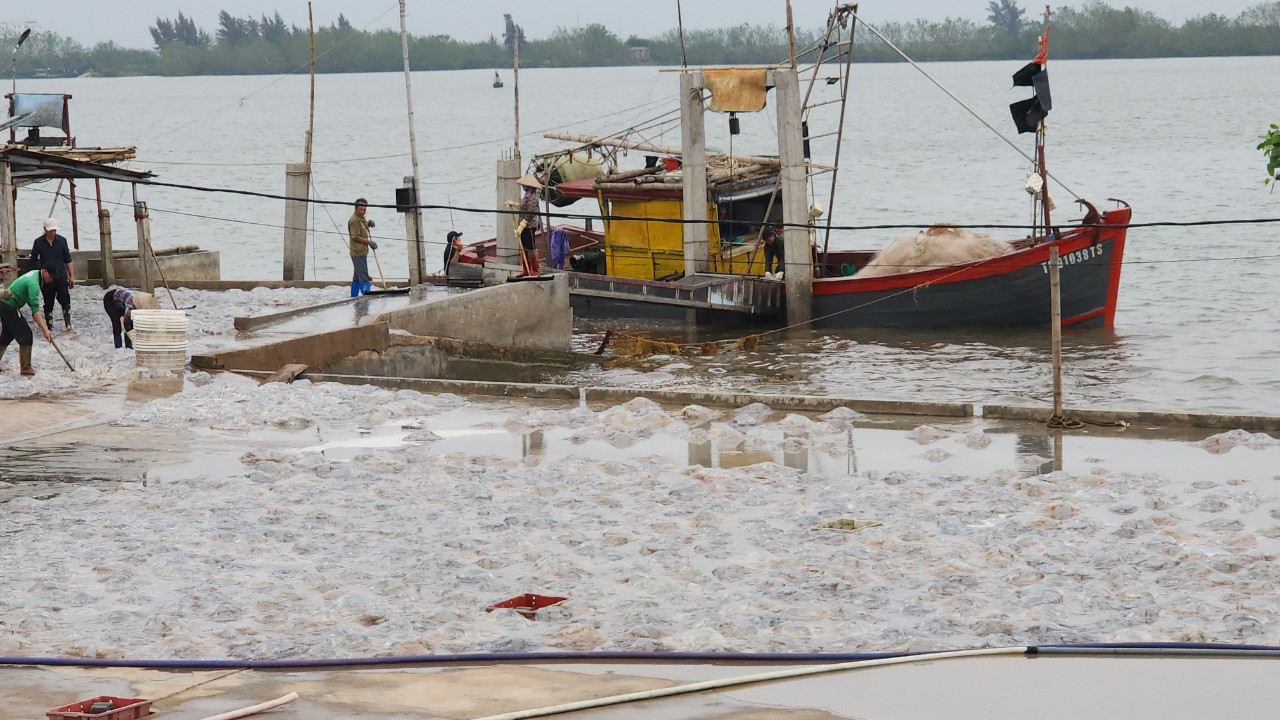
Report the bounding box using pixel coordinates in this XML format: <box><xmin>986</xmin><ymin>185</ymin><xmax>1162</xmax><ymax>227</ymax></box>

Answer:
<box><xmin>680</xmin><ymin>70</ymin><xmax>710</xmax><ymax>277</ymax></box>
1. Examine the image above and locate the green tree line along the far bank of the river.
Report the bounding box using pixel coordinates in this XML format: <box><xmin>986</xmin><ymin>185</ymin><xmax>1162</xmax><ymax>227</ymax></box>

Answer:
<box><xmin>0</xmin><ymin>0</ymin><xmax>1280</xmax><ymax>77</ymax></box>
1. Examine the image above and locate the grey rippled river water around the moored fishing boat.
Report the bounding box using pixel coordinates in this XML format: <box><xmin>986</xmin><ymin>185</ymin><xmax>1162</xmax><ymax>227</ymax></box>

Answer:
<box><xmin>18</xmin><ymin>58</ymin><xmax>1280</xmax><ymax>414</ymax></box>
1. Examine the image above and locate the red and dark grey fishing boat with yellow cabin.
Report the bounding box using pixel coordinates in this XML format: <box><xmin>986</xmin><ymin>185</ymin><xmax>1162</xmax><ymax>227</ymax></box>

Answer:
<box><xmin>461</xmin><ymin>5</ymin><xmax>1130</xmax><ymax>328</ymax></box>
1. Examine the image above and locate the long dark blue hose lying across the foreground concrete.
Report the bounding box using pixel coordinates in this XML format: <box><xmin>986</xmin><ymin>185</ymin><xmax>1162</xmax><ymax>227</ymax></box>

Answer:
<box><xmin>0</xmin><ymin>642</ymin><xmax>1280</xmax><ymax>670</ymax></box>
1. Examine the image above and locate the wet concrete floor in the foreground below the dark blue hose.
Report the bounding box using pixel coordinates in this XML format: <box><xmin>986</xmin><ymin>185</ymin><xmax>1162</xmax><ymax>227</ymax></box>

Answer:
<box><xmin>0</xmin><ymin>655</ymin><xmax>1280</xmax><ymax>720</ymax></box>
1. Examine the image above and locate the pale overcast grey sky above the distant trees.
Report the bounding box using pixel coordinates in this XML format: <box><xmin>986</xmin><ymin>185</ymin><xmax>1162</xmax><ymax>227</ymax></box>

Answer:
<box><xmin>0</xmin><ymin>0</ymin><xmax>1261</xmax><ymax>47</ymax></box>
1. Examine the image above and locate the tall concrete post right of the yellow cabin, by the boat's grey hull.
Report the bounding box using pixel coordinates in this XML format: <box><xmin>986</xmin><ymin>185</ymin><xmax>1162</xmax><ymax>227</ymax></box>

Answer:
<box><xmin>773</xmin><ymin>70</ymin><xmax>813</xmax><ymax>325</ymax></box>
